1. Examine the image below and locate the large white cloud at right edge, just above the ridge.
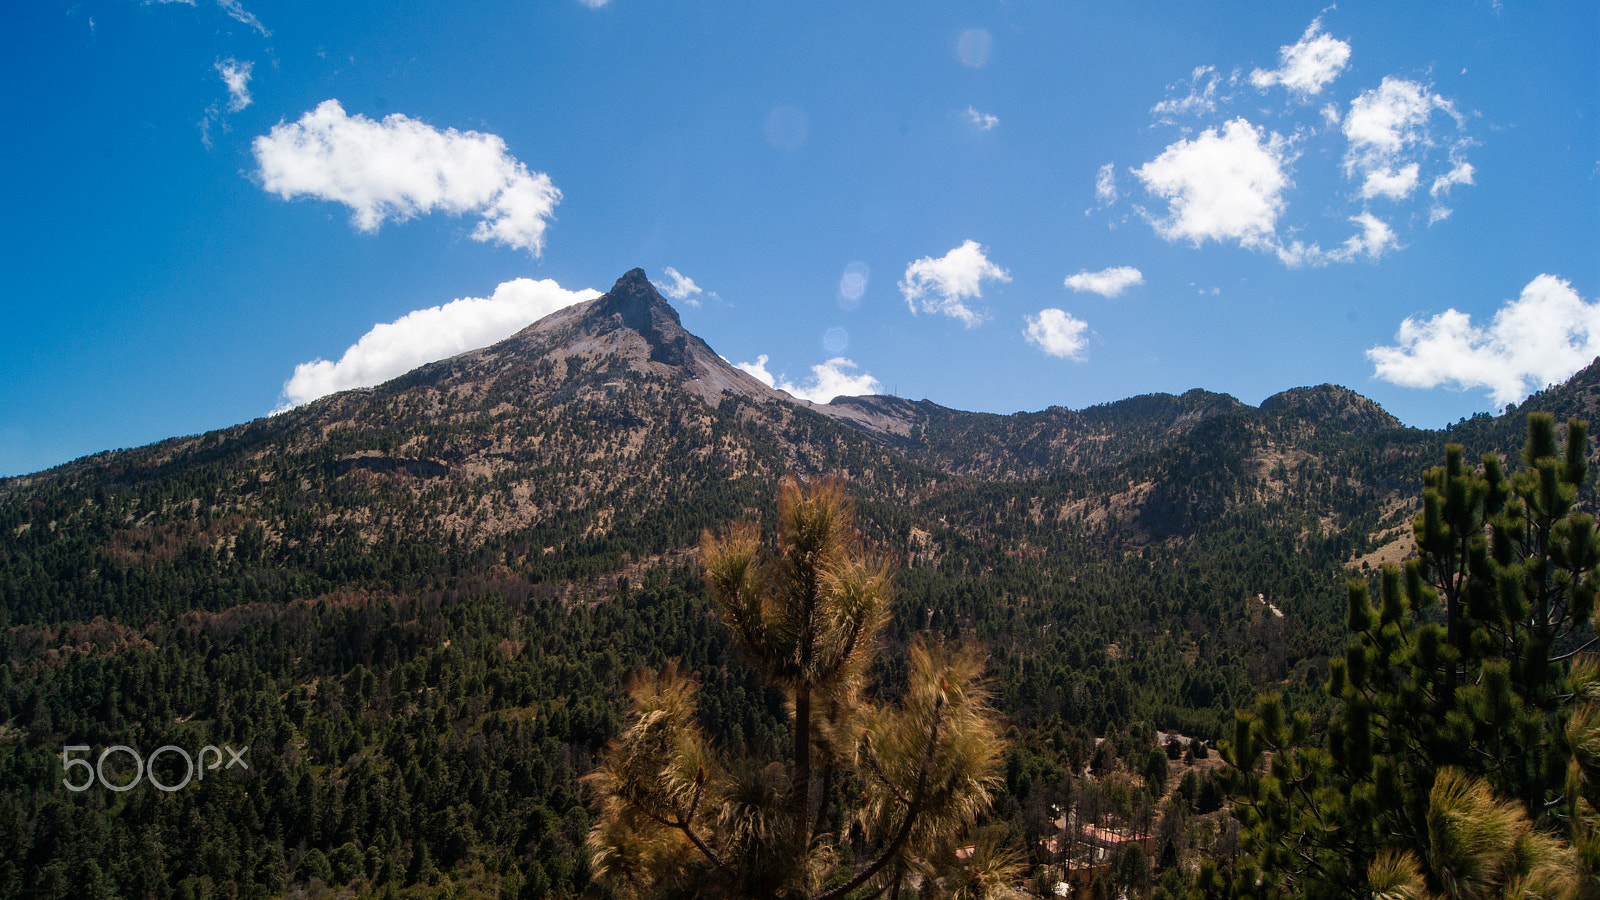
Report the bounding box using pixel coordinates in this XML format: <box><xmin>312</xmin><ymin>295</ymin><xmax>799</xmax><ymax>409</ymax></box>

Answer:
<box><xmin>1366</xmin><ymin>269</ymin><xmax>1600</xmax><ymax>407</ymax></box>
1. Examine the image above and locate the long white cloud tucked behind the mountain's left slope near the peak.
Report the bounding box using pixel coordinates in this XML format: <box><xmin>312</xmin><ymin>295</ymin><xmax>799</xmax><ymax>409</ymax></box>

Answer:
<box><xmin>274</xmin><ymin>279</ymin><xmax>600</xmax><ymax>412</ymax></box>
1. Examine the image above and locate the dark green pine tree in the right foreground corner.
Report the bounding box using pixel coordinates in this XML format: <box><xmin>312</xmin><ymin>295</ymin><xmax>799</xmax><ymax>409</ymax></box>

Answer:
<box><xmin>1224</xmin><ymin>415</ymin><xmax>1600</xmax><ymax>897</ymax></box>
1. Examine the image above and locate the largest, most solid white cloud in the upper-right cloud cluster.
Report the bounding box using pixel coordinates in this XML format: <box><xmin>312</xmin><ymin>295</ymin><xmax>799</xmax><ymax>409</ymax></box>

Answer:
<box><xmin>1133</xmin><ymin>119</ymin><xmax>1291</xmax><ymax>250</ymax></box>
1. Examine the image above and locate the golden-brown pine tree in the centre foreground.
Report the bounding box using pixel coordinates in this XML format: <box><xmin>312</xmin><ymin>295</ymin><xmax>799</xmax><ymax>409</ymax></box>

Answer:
<box><xmin>586</xmin><ymin>479</ymin><xmax>1014</xmax><ymax>900</ymax></box>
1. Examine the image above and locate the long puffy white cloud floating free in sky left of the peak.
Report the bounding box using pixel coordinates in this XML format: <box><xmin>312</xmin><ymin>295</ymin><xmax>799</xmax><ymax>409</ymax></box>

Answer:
<box><xmin>254</xmin><ymin>99</ymin><xmax>562</xmax><ymax>256</ymax></box>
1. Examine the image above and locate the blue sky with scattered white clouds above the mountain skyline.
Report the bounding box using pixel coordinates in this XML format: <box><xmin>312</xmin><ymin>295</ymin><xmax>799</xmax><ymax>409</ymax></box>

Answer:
<box><xmin>0</xmin><ymin>0</ymin><xmax>1600</xmax><ymax>476</ymax></box>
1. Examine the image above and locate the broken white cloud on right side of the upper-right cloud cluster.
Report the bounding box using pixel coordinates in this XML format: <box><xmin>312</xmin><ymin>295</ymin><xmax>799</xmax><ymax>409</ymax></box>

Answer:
<box><xmin>1344</xmin><ymin>75</ymin><xmax>1470</xmax><ymax>200</ymax></box>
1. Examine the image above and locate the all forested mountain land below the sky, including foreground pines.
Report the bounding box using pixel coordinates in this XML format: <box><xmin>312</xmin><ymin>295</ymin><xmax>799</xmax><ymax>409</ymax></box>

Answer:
<box><xmin>0</xmin><ymin>282</ymin><xmax>1600</xmax><ymax>900</ymax></box>
